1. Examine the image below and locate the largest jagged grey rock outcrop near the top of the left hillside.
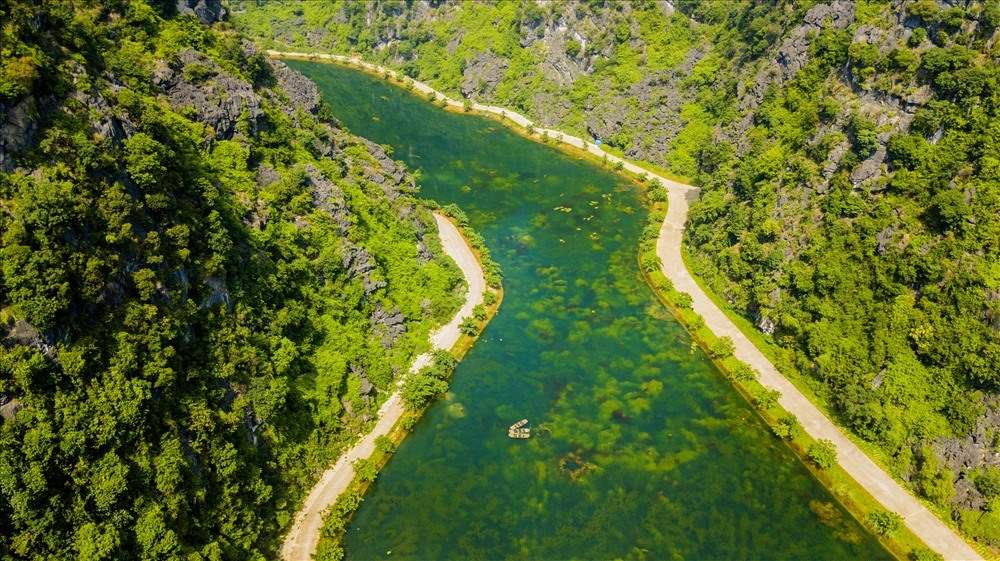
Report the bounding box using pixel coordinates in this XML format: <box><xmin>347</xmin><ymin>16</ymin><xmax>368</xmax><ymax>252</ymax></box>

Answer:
<box><xmin>153</xmin><ymin>50</ymin><xmax>264</xmax><ymax>139</ymax></box>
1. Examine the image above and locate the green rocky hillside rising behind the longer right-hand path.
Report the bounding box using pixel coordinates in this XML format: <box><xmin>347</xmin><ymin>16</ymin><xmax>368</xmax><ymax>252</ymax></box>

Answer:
<box><xmin>234</xmin><ymin>0</ymin><xmax>1000</xmax><ymax>545</ymax></box>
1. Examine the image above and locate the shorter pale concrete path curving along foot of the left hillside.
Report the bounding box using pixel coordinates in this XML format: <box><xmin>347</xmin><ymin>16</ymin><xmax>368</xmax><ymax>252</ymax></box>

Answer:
<box><xmin>281</xmin><ymin>213</ymin><xmax>486</xmax><ymax>561</ymax></box>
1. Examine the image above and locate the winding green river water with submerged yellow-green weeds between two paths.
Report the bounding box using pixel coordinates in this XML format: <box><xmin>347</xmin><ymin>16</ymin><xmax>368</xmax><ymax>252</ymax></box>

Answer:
<box><xmin>290</xmin><ymin>62</ymin><xmax>889</xmax><ymax>561</ymax></box>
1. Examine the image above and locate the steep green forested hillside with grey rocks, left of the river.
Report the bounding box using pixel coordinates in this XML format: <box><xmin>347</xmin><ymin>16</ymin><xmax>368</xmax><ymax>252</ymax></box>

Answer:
<box><xmin>0</xmin><ymin>0</ymin><xmax>464</xmax><ymax>561</ymax></box>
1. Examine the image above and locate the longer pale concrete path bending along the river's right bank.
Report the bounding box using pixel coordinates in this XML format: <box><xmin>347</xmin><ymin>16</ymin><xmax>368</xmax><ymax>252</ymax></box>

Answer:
<box><xmin>267</xmin><ymin>50</ymin><xmax>983</xmax><ymax>561</ymax></box>
